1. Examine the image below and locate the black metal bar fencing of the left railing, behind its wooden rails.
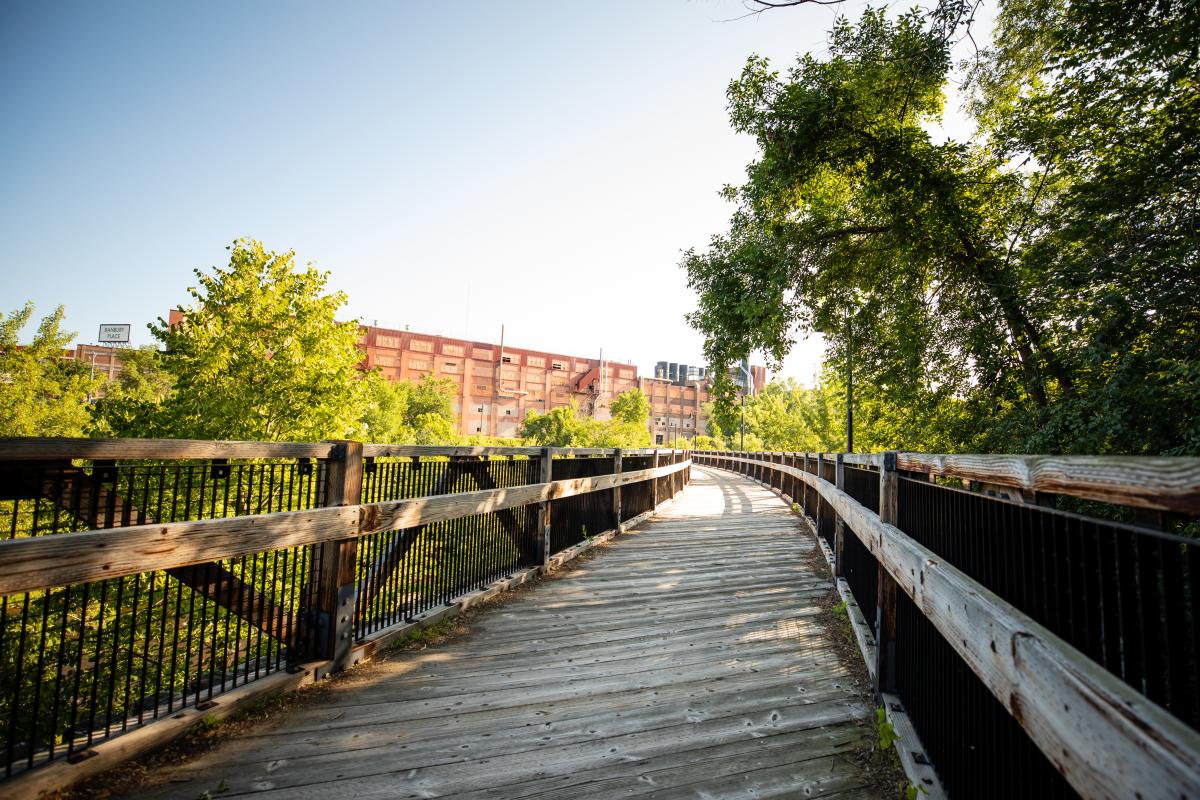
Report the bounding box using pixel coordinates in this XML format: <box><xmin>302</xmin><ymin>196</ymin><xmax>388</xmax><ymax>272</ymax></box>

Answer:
<box><xmin>0</xmin><ymin>443</ymin><xmax>685</xmax><ymax>776</ymax></box>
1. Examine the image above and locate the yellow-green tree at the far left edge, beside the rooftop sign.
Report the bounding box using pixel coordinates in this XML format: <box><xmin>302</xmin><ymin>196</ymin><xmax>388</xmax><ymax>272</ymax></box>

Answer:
<box><xmin>0</xmin><ymin>303</ymin><xmax>100</xmax><ymax>437</ymax></box>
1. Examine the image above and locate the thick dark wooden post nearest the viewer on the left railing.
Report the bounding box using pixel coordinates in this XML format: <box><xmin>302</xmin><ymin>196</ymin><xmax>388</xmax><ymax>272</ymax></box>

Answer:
<box><xmin>317</xmin><ymin>440</ymin><xmax>362</xmax><ymax>672</ymax></box>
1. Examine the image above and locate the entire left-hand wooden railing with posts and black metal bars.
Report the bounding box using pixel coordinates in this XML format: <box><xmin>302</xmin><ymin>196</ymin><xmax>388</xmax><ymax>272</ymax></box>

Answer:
<box><xmin>0</xmin><ymin>439</ymin><xmax>690</xmax><ymax>796</ymax></box>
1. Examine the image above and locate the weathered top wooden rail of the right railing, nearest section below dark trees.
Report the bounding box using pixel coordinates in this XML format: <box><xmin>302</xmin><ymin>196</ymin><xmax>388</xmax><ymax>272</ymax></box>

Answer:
<box><xmin>899</xmin><ymin>453</ymin><xmax>1200</xmax><ymax>515</ymax></box>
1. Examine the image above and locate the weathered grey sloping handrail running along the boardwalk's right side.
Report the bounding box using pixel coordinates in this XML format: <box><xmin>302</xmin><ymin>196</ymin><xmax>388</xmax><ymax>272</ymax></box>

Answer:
<box><xmin>701</xmin><ymin>453</ymin><xmax>1200</xmax><ymax>799</ymax></box>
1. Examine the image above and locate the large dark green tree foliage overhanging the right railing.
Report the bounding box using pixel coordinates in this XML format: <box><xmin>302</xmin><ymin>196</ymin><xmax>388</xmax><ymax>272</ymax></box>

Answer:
<box><xmin>684</xmin><ymin>0</ymin><xmax>1200</xmax><ymax>452</ymax></box>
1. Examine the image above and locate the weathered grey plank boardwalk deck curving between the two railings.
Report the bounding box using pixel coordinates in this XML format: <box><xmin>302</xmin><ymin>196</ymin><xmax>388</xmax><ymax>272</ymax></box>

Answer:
<box><xmin>138</xmin><ymin>467</ymin><xmax>876</xmax><ymax>800</ymax></box>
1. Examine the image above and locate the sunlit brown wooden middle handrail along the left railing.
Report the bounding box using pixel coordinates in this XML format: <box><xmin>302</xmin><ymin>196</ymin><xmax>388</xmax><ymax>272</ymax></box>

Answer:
<box><xmin>0</xmin><ymin>459</ymin><xmax>691</xmax><ymax>595</ymax></box>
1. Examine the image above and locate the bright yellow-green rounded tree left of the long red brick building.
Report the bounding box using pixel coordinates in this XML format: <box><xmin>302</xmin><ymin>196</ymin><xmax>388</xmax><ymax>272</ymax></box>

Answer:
<box><xmin>145</xmin><ymin>239</ymin><xmax>377</xmax><ymax>440</ymax></box>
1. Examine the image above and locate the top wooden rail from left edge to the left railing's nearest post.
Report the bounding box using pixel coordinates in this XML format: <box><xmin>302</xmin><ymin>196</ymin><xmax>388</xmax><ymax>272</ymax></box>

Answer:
<box><xmin>0</xmin><ymin>437</ymin><xmax>336</xmax><ymax>461</ymax></box>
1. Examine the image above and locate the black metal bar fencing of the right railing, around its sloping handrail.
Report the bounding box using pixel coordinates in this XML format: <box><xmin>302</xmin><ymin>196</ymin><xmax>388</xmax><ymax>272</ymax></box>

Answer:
<box><xmin>697</xmin><ymin>453</ymin><xmax>1200</xmax><ymax>799</ymax></box>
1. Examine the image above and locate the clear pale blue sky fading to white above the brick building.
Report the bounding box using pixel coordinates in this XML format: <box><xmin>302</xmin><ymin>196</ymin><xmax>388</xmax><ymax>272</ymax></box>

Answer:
<box><xmin>0</xmin><ymin>0</ymin><xmax>988</xmax><ymax>380</ymax></box>
